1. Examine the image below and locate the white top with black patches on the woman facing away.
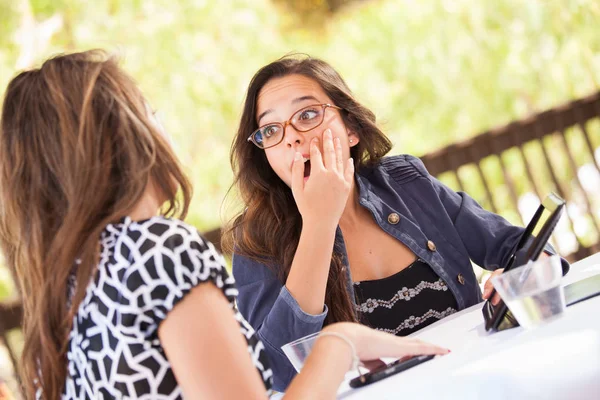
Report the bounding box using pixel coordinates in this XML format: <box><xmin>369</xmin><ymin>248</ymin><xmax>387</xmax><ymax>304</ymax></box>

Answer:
<box><xmin>63</xmin><ymin>217</ymin><xmax>272</xmax><ymax>399</ymax></box>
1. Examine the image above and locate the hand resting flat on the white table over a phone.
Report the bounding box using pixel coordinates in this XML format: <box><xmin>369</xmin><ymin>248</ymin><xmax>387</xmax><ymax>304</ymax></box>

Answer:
<box><xmin>323</xmin><ymin>322</ymin><xmax>450</xmax><ymax>361</ymax></box>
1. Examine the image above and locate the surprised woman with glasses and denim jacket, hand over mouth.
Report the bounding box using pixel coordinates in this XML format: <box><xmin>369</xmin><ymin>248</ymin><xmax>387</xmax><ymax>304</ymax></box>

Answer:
<box><xmin>223</xmin><ymin>57</ymin><xmax>564</xmax><ymax>390</ymax></box>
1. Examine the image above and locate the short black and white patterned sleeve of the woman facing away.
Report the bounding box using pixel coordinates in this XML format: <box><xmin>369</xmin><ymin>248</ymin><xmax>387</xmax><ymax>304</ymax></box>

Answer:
<box><xmin>116</xmin><ymin>220</ymin><xmax>237</xmax><ymax>337</ymax></box>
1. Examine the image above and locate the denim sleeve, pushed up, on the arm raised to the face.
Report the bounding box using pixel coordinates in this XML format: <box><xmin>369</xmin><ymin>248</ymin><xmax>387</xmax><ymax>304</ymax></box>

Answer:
<box><xmin>232</xmin><ymin>254</ymin><xmax>327</xmax><ymax>392</ymax></box>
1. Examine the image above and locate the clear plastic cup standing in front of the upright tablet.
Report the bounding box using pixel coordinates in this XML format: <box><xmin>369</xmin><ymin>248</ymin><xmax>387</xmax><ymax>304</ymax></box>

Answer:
<box><xmin>492</xmin><ymin>256</ymin><xmax>566</xmax><ymax>328</ymax></box>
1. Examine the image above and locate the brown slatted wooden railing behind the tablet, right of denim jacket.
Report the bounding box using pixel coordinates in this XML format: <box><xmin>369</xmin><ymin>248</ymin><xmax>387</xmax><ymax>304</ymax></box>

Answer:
<box><xmin>421</xmin><ymin>92</ymin><xmax>600</xmax><ymax>261</ymax></box>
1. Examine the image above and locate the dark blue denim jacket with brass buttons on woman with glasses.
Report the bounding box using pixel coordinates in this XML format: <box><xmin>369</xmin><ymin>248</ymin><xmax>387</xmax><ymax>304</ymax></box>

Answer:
<box><xmin>233</xmin><ymin>155</ymin><xmax>568</xmax><ymax>391</ymax></box>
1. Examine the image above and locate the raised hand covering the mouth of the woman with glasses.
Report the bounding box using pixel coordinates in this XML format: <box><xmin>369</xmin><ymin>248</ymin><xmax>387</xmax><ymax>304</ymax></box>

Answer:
<box><xmin>292</xmin><ymin>129</ymin><xmax>354</xmax><ymax>226</ymax></box>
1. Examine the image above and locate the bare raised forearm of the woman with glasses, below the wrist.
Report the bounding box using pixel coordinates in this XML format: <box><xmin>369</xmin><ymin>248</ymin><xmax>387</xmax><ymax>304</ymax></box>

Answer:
<box><xmin>285</xmin><ymin>223</ymin><xmax>336</xmax><ymax>315</ymax></box>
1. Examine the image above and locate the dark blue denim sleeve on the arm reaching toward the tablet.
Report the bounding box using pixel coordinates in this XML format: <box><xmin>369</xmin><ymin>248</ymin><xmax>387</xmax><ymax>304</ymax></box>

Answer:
<box><xmin>410</xmin><ymin>156</ymin><xmax>569</xmax><ymax>274</ymax></box>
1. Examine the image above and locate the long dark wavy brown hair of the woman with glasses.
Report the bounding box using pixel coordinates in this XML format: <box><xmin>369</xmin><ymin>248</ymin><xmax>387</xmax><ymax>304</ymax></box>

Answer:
<box><xmin>223</xmin><ymin>56</ymin><xmax>392</xmax><ymax>324</ymax></box>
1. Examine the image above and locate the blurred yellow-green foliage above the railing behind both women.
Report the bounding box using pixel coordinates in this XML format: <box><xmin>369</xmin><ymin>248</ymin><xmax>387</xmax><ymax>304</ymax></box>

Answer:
<box><xmin>0</xmin><ymin>0</ymin><xmax>600</xmax><ymax>284</ymax></box>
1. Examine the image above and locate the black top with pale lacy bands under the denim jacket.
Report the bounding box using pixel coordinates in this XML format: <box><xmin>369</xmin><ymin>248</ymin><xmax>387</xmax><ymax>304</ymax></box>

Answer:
<box><xmin>354</xmin><ymin>259</ymin><xmax>458</xmax><ymax>336</ymax></box>
